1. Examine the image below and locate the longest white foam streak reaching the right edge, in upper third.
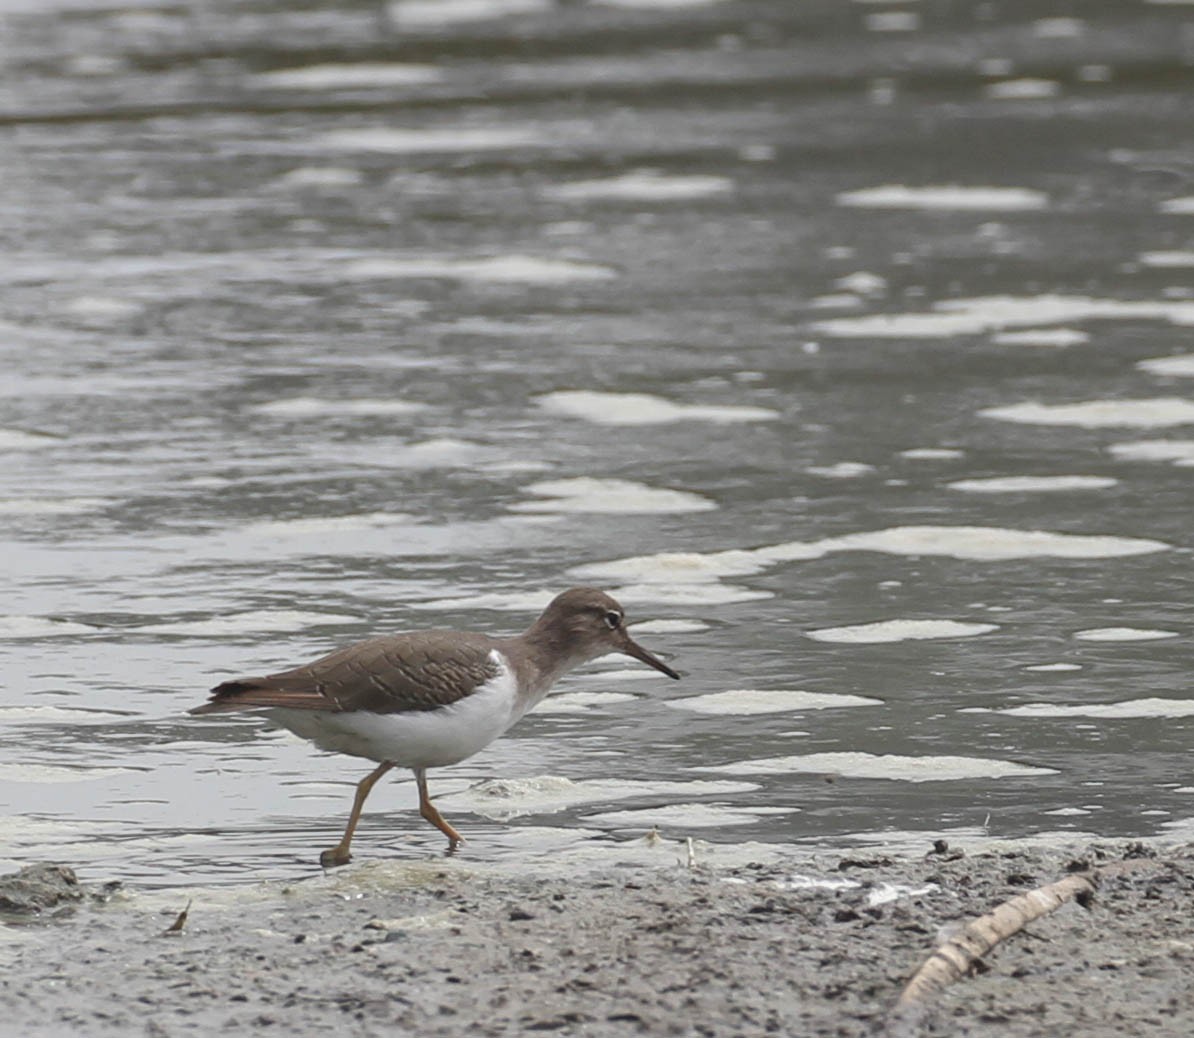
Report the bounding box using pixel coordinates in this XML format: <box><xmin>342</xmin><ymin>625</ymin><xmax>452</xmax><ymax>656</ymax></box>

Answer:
<box><xmin>811</xmin><ymin>295</ymin><xmax>1194</xmax><ymax>339</ymax></box>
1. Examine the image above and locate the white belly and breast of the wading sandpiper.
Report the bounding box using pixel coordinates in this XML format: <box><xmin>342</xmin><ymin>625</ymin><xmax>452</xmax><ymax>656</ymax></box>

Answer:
<box><xmin>267</xmin><ymin>651</ymin><xmax>522</xmax><ymax>768</ymax></box>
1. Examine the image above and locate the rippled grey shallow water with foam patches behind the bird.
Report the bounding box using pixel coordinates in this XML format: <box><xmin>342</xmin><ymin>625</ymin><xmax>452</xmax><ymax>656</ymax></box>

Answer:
<box><xmin>0</xmin><ymin>0</ymin><xmax>1194</xmax><ymax>885</ymax></box>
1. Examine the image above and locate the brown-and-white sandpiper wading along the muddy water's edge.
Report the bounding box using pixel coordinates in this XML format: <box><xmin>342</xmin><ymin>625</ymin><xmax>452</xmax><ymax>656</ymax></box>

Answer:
<box><xmin>190</xmin><ymin>588</ymin><xmax>679</xmax><ymax>867</ymax></box>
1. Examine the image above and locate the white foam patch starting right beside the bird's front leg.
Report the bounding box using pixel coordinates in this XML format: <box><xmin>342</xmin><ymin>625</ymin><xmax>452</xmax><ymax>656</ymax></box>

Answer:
<box><xmin>437</xmin><ymin>775</ymin><xmax>758</xmax><ymax>822</ymax></box>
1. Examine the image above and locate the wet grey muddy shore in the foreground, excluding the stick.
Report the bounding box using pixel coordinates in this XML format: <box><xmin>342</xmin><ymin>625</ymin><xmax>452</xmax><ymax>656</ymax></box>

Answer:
<box><xmin>0</xmin><ymin>837</ymin><xmax>1194</xmax><ymax>1038</ymax></box>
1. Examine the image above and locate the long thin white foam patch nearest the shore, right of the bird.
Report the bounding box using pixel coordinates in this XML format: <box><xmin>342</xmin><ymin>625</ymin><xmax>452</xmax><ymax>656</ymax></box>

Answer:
<box><xmin>696</xmin><ymin>753</ymin><xmax>1058</xmax><ymax>782</ymax></box>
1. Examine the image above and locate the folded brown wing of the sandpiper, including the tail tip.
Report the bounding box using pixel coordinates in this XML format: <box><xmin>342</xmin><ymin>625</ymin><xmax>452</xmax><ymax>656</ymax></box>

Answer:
<box><xmin>190</xmin><ymin>631</ymin><xmax>499</xmax><ymax>713</ymax></box>
